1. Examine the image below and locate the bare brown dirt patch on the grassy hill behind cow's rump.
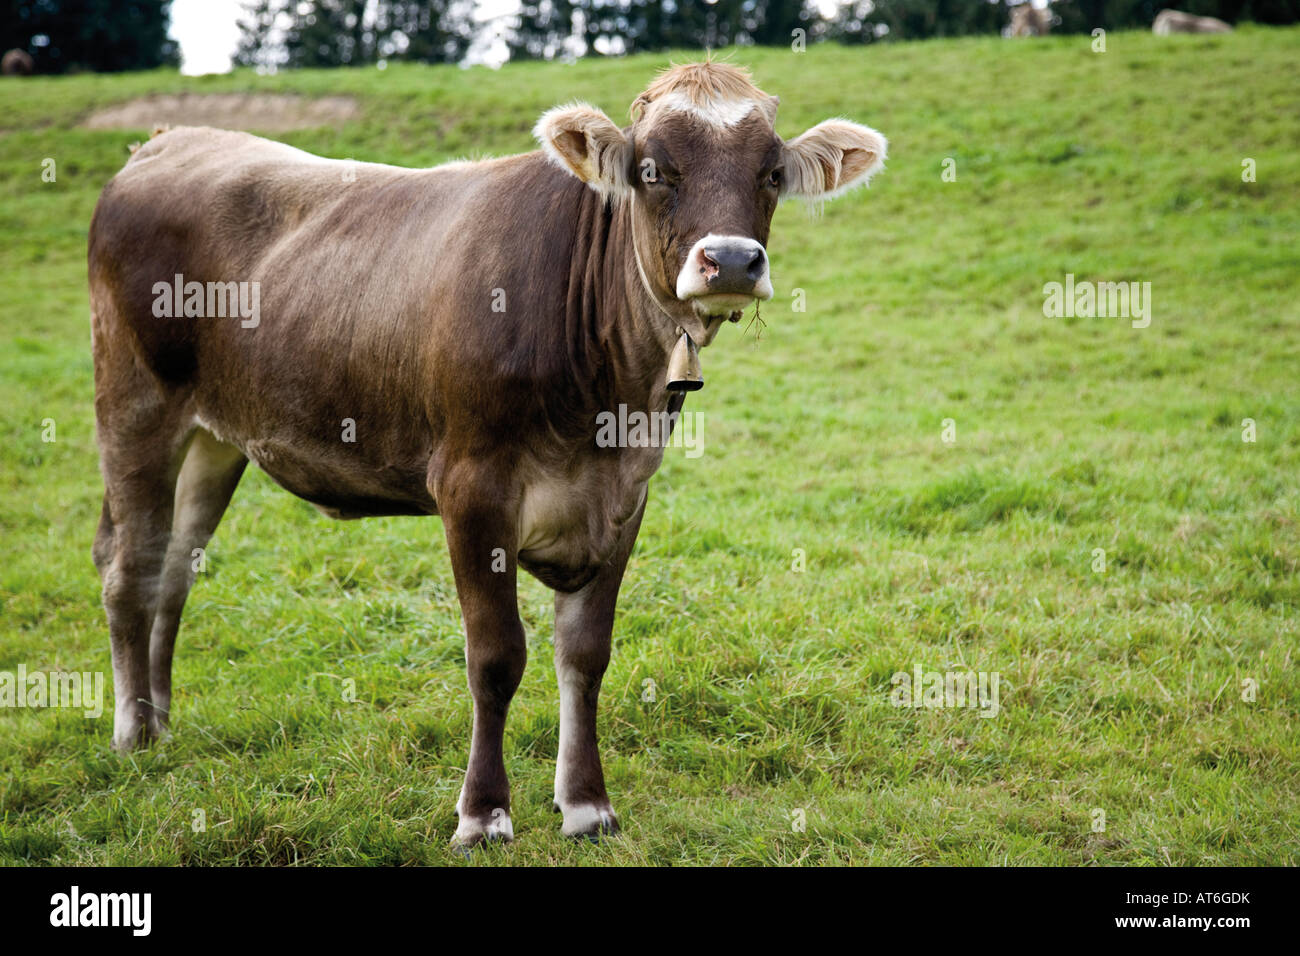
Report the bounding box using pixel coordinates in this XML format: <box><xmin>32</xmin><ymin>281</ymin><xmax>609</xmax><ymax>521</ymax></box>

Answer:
<box><xmin>82</xmin><ymin>92</ymin><xmax>361</xmax><ymax>133</ymax></box>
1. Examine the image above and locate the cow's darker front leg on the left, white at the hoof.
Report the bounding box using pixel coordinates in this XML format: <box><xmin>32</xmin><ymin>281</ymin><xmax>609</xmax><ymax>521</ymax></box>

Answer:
<box><xmin>439</xmin><ymin>479</ymin><xmax>528</xmax><ymax>847</ymax></box>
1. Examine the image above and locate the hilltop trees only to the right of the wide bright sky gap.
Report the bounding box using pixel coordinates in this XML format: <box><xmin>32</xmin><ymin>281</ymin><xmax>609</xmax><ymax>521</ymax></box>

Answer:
<box><xmin>237</xmin><ymin>0</ymin><xmax>1300</xmax><ymax>66</ymax></box>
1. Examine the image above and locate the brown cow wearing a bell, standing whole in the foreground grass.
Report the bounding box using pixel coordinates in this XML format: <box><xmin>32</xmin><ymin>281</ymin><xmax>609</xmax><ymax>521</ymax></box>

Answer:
<box><xmin>90</xmin><ymin>62</ymin><xmax>885</xmax><ymax>845</ymax></box>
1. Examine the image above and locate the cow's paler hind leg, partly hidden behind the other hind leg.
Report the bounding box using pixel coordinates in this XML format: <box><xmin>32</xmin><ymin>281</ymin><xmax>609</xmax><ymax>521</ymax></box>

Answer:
<box><xmin>150</xmin><ymin>428</ymin><xmax>248</xmax><ymax>728</ymax></box>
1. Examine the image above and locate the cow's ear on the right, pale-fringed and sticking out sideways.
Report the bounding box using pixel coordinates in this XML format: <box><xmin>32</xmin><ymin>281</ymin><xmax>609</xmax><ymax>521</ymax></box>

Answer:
<box><xmin>783</xmin><ymin>120</ymin><xmax>889</xmax><ymax>199</ymax></box>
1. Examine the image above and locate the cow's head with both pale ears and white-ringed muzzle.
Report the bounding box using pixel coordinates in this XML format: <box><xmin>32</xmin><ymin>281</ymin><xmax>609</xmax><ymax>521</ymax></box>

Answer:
<box><xmin>534</xmin><ymin>62</ymin><xmax>887</xmax><ymax>345</ymax></box>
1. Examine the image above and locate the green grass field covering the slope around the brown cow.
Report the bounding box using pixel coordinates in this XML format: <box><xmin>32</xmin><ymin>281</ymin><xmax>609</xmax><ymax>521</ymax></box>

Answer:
<box><xmin>0</xmin><ymin>27</ymin><xmax>1300</xmax><ymax>866</ymax></box>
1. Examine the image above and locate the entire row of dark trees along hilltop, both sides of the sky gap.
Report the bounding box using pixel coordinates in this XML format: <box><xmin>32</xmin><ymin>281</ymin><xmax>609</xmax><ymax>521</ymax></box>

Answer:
<box><xmin>0</xmin><ymin>0</ymin><xmax>1300</xmax><ymax>73</ymax></box>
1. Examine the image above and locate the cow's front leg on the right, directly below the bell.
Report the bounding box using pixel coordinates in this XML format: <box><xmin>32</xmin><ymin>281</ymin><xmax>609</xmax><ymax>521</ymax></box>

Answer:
<box><xmin>555</xmin><ymin>496</ymin><xmax>645</xmax><ymax>839</ymax></box>
